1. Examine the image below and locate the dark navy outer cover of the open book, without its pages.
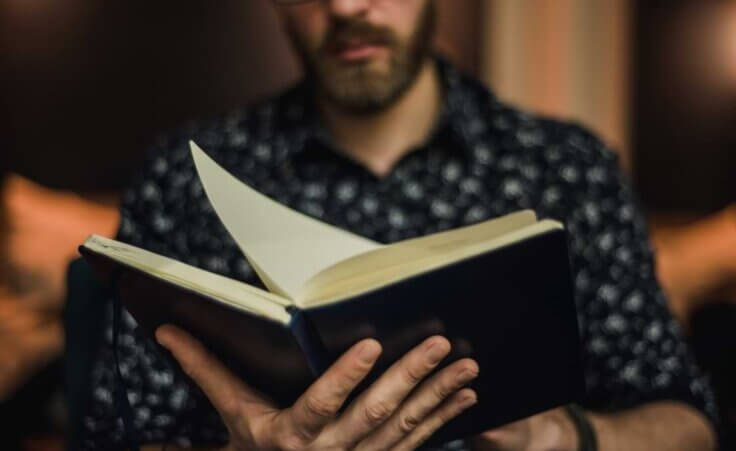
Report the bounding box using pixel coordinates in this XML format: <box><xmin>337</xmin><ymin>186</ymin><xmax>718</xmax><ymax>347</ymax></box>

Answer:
<box><xmin>80</xmin><ymin>230</ymin><xmax>584</xmax><ymax>443</ymax></box>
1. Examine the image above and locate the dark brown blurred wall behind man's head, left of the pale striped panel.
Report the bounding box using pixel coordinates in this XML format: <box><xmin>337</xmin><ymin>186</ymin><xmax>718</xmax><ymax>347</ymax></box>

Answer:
<box><xmin>0</xmin><ymin>0</ymin><xmax>481</xmax><ymax>191</ymax></box>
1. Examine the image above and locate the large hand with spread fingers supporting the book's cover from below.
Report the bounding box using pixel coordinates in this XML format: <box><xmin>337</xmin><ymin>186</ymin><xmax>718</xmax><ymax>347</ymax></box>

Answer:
<box><xmin>156</xmin><ymin>326</ymin><xmax>478</xmax><ymax>450</ymax></box>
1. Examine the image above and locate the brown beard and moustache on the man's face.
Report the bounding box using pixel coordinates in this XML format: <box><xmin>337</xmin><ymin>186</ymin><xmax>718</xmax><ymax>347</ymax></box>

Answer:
<box><xmin>288</xmin><ymin>0</ymin><xmax>435</xmax><ymax>114</ymax></box>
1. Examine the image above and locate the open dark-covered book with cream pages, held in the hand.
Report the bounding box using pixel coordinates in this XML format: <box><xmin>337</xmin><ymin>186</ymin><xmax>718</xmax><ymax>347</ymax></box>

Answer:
<box><xmin>80</xmin><ymin>143</ymin><xmax>583</xmax><ymax>440</ymax></box>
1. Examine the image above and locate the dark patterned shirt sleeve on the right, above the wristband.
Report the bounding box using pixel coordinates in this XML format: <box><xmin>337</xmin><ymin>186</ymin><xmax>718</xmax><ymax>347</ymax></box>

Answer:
<box><xmin>541</xmin><ymin>127</ymin><xmax>716</xmax><ymax>422</ymax></box>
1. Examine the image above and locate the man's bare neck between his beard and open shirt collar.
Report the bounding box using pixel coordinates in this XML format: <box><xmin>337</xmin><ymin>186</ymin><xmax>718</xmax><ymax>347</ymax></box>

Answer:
<box><xmin>321</xmin><ymin>59</ymin><xmax>442</xmax><ymax>176</ymax></box>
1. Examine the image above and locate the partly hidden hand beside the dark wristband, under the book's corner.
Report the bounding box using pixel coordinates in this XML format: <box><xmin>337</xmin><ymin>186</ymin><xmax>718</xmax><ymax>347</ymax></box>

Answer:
<box><xmin>473</xmin><ymin>408</ymin><xmax>578</xmax><ymax>451</ymax></box>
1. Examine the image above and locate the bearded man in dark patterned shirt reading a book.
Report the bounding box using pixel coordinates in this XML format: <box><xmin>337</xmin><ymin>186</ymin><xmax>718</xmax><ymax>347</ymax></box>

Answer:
<box><xmin>85</xmin><ymin>0</ymin><xmax>715</xmax><ymax>450</ymax></box>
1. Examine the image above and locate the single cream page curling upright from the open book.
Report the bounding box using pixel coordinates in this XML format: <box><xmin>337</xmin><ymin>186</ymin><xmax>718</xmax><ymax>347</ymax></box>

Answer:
<box><xmin>190</xmin><ymin>142</ymin><xmax>382</xmax><ymax>299</ymax></box>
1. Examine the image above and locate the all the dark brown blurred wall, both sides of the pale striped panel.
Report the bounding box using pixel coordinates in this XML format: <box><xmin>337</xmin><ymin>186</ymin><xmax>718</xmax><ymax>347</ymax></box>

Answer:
<box><xmin>0</xmin><ymin>0</ymin><xmax>736</xmax><ymax>217</ymax></box>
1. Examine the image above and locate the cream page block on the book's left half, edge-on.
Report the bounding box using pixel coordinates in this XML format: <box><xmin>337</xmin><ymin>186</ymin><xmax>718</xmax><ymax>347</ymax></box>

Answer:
<box><xmin>82</xmin><ymin>235</ymin><xmax>292</xmax><ymax>324</ymax></box>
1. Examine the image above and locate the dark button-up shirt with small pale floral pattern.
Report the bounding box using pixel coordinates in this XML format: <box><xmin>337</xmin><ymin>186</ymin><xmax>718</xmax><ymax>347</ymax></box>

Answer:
<box><xmin>79</xmin><ymin>61</ymin><xmax>714</xmax><ymax>449</ymax></box>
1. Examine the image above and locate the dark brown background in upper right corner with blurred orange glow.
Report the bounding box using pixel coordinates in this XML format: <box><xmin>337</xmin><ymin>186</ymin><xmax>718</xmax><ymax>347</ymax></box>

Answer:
<box><xmin>631</xmin><ymin>0</ymin><xmax>736</xmax><ymax>214</ymax></box>
